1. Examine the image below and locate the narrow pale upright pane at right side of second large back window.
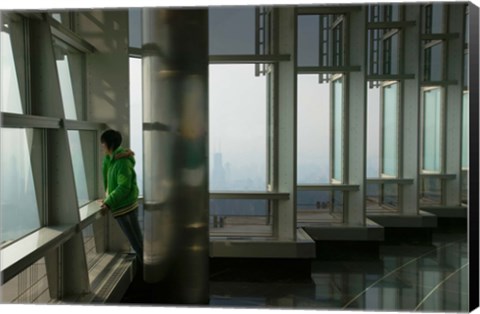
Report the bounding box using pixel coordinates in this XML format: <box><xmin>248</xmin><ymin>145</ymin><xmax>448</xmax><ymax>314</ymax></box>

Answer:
<box><xmin>332</xmin><ymin>78</ymin><xmax>343</xmax><ymax>182</ymax></box>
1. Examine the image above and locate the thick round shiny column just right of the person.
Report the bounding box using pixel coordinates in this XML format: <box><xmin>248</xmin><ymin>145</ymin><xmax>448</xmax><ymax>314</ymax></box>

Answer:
<box><xmin>142</xmin><ymin>9</ymin><xmax>209</xmax><ymax>304</ymax></box>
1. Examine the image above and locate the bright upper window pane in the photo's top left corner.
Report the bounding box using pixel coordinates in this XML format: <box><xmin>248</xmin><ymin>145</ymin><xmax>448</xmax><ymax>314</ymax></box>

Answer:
<box><xmin>0</xmin><ymin>15</ymin><xmax>25</xmax><ymax>113</ymax></box>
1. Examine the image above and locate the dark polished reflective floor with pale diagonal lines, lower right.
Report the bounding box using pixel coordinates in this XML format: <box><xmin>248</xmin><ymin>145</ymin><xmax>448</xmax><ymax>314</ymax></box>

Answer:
<box><xmin>124</xmin><ymin>227</ymin><xmax>468</xmax><ymax>312</ymax></box>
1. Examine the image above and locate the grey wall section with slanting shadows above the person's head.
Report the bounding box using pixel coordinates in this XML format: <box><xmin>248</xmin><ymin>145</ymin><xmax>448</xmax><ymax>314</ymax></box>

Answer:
<box><xmin>77</xmin><ymin>10</ymin><xmax>130</xmax><ymax>139</ymax></box>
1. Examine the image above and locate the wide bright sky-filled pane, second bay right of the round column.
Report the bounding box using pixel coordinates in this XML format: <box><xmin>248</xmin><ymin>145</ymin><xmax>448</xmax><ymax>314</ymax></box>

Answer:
<box><xmin>297</xmin><ymin>75</ymin><xmax>330</xmax><ymax>184</ymax></box>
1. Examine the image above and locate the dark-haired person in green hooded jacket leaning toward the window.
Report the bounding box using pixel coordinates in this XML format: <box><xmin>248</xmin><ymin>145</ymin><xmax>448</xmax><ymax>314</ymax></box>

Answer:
<box><xmin>100</xmin><ymin>130</ymin><xmax>143</xmax><ymax>263</ymax></box>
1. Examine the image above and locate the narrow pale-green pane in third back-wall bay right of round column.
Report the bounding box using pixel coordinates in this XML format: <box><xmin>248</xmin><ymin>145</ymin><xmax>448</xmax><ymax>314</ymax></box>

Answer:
<box><xmin>382</xmin><ymin>83</ymin><xmax>398</xmax><ymax>177</ymax></box>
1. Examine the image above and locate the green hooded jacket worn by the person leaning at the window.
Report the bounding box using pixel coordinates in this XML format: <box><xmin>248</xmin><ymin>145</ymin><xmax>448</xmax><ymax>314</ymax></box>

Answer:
<box><xmin>102</xmin><ymin>146</ymin><xmax>138</xmax><ymax>217</ymax></box>
